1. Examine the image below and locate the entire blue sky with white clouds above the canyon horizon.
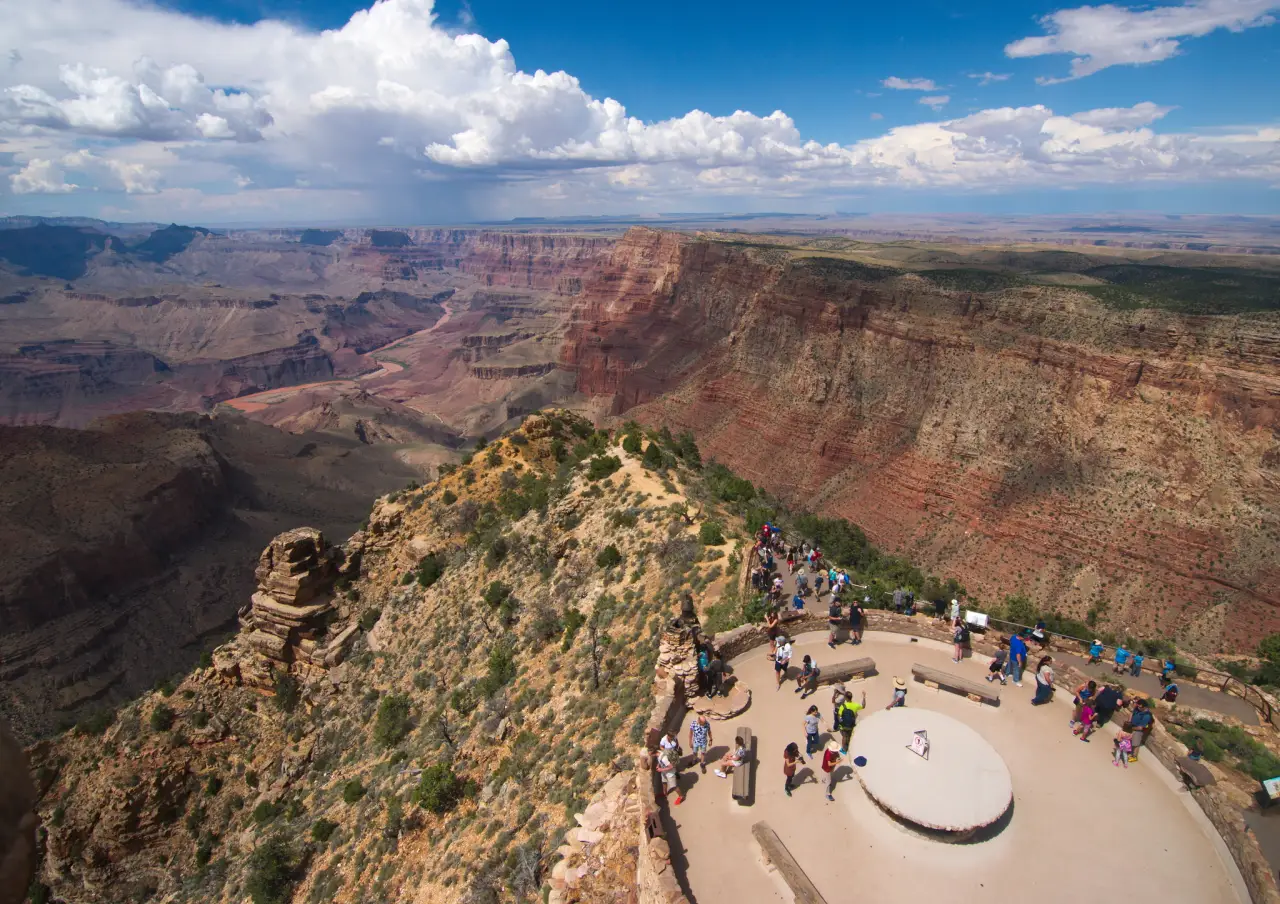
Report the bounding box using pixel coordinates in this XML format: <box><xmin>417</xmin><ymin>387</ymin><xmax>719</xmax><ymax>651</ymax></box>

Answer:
<box><xmin>0</xmin><ymin>0</ymin><xmax>1280</xmax><ymax>222</ymax></box>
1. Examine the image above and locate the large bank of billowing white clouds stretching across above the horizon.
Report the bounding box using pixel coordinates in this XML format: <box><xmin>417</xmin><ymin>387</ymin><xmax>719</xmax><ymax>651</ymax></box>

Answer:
<box><xmin>0</xmin><ymin>0</ymin><xmax>1280</xmax><ymax>222</ymax></box>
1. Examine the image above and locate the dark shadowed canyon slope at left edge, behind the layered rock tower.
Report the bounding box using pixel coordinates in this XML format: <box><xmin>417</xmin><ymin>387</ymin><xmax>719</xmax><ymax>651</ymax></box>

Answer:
<box><xmin>0</xmin><ymin>412</ymin><xmax>422</xmax><ymax>738</ymax></box>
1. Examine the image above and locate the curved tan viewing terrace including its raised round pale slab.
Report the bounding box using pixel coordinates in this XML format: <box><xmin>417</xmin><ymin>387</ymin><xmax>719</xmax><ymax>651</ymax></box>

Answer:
<box><xmin>664</xmin><ymin>631</ymin><xmax>1249</xmax><ymax>904</ymax></box>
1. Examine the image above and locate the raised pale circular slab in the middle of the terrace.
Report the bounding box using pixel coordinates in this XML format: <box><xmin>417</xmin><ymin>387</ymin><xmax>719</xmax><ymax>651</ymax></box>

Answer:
<box><xmin>849</xmin><ymin>707</ymin><xmax>1014</xmax><ymax>841</ymax></box>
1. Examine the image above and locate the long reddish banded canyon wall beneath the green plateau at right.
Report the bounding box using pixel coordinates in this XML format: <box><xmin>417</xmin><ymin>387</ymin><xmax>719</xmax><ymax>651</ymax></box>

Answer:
<box><xmin>561</xmin><ymin>229</ymin><xmax>1280</xmax><ymax>649</ymax></box>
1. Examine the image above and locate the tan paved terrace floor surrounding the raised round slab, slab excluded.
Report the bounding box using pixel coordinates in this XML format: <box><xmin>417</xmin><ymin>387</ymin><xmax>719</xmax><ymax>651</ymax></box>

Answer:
<box><xmin>669</xmin><ymin>633</ymin><xmax>1248</xmax><ymax>904</ymax></box>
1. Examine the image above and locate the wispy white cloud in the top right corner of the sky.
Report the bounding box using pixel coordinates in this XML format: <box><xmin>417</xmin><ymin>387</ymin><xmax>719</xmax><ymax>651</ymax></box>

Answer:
<box><xmin>1005</xmin><ymin>0</ymin><xmax>1280</xmax><ymax>82</ymax></box>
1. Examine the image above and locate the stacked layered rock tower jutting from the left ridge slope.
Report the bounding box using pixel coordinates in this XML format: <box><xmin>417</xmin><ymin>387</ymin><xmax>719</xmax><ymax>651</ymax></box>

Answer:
<box><xmin>215</xmin><ymin>528</ymin><xmax>362</xmax><ymax>690</ymax></box>
